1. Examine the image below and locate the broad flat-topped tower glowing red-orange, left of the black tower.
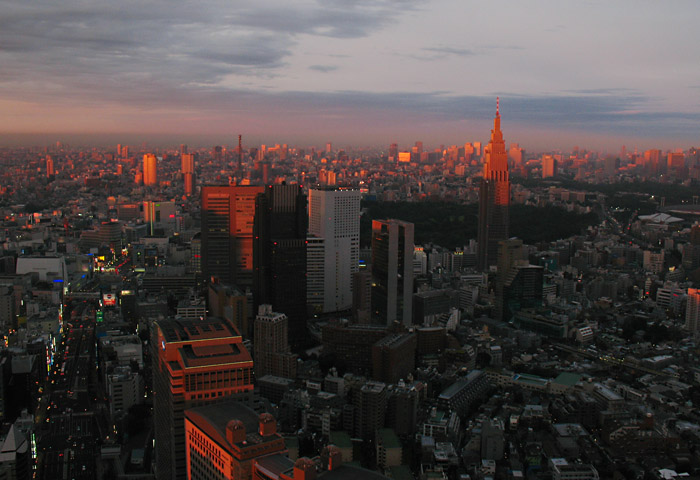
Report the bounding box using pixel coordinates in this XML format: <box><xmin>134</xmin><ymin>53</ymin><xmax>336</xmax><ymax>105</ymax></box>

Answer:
<box><xmin>202</xmin><ymin>185</ymin><xmax>265</xmax><ymax>289</ymax></box>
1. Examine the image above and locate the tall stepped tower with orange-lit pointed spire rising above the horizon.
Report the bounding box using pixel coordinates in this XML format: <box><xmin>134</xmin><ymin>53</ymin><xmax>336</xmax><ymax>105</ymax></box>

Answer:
<box><xmin>477</xmin><ymin>100</ymin><xmax>510</xmax><ymax>270</ymax></box>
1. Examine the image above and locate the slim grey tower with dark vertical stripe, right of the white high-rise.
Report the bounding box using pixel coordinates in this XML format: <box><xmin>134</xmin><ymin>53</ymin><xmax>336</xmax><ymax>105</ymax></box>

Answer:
<box><xmin>371</xmin><ymin>219</ymin><xmax>413</xmax><ymax>326</ymax></box>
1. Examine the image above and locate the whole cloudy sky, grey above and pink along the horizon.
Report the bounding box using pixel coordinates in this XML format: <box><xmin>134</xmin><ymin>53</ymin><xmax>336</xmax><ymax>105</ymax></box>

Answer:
<box><xmin>0</xmin><ymin>0</ymin><xmax>700</xmax><ymax>151</ymax></box>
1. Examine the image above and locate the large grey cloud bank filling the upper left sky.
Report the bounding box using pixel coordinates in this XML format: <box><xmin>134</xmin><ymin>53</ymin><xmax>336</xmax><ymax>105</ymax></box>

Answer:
<box><xmin>0</xmin><ymin>0</ymin><xmax>417</xmax><ymax>99</ymax></box>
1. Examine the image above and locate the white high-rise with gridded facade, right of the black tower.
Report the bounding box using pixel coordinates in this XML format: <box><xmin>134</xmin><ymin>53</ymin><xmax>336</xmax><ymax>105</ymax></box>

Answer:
<box><xmin>307</xmin><ymin>188</ymin><xmax>361</xmax><ymax>313</ymax></box>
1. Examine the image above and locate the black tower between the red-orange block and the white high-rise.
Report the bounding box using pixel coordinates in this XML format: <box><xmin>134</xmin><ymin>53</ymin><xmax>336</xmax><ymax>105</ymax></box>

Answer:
<box><xmin>253</xmin><ymin>185</ymin><xmax>308</xmax><ymax>347</ymax></box>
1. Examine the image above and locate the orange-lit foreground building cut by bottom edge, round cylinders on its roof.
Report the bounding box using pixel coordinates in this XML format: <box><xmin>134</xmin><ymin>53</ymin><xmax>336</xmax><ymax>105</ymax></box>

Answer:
<box><xmin>185</xmin><ymin>402</ymin><xmax>286</xmax><ymax>480</ymax></box>
